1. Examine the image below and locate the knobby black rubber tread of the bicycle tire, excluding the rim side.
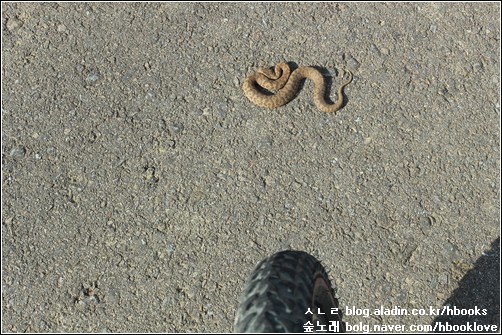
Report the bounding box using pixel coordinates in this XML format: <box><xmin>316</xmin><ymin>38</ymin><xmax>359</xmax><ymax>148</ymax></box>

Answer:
<box><xmin>234</xmin><ymin>251</ymin><xmax>333</xmax><ymax>333</ymax></box>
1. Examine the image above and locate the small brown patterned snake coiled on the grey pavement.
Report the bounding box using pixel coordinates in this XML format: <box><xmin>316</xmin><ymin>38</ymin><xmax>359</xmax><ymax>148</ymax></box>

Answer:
<box><xmin>242</xmin><ymin>63</ymin><xmax>352</xmax><ymax>113</ymax></box>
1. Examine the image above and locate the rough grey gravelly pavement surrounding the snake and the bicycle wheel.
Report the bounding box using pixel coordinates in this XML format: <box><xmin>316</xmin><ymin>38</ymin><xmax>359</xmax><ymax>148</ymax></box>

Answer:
<box><xmin>2</xmin><ymin>3</ymin><xmax>500</xmax><ymax>332</ymax></box>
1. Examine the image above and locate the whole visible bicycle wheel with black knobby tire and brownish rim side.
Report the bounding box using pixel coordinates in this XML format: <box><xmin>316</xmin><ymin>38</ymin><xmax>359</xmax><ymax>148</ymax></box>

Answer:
<box><xmin>234</xmin><ymin>251</ymin><xmax>345</xmax><ymax>333</ymax></box>
